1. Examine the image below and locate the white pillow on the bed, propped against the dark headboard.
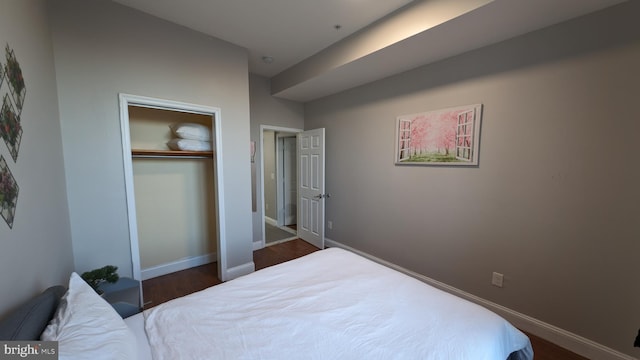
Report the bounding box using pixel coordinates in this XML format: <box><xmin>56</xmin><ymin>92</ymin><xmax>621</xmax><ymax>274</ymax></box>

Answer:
<box><xmin>41</xmin><ymin>272</ymin><xmax>137</xmax><ymax>360</ymax></box>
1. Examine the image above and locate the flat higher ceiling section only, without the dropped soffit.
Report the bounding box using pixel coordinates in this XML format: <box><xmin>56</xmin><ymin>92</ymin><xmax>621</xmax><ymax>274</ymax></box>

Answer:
<box><xmin>114</xmin><ymin>0</ymin><xmax>411</xmax><ymax>77</ymax></box>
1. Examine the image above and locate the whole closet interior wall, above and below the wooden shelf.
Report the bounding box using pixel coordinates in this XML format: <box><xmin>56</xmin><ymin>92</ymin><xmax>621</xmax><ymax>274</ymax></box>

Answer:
<box><xmin>129</xmin><ymin>106</ymin><xmax>217</xmax><ymax>280</ymax></box>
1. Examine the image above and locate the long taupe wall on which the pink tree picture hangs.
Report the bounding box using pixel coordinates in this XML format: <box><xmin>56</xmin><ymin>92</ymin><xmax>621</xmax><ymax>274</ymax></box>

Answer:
<box><xmin>305</xmin><ymin>2</ymin><xmax>640</xmax><ymax>357</ymax></box>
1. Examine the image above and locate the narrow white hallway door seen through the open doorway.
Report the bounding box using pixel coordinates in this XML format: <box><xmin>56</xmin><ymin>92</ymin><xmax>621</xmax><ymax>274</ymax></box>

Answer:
<box><xmin>282</xmin><ymin>136</ymin><xmax>298</xmax><ymax>225</ymax></box>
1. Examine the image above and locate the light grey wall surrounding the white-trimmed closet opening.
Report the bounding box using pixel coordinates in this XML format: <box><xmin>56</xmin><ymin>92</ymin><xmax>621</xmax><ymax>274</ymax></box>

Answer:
<box><xmin>49</xmin><ymin>0</ymin><xmax>253</xmax><ymax>276</ymax></box>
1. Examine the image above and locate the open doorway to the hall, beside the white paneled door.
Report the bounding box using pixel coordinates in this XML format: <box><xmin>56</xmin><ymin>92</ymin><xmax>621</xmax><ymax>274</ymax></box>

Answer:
<box><xmin>259</xmin><ymin>125</ymin><xmax>302</xmax><ymax>247</ymax></box>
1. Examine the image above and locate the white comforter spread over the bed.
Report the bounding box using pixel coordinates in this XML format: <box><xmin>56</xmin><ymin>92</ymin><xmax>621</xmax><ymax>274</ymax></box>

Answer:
<box><xmin>144</xmin><ymin>249</ymin><xmax>533</xmax><ymax>360</ymax></box>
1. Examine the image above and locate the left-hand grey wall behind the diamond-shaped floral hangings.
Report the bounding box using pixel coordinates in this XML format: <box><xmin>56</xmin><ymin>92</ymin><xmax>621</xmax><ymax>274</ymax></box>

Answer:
<box><xmin>0</xmin><ymin>0</ymin><xmax>73</xmax><ymax>318</ymax></box>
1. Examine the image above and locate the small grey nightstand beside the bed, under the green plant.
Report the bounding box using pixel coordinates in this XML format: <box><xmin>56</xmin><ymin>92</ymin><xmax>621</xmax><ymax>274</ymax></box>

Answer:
<box><xmin>100</xmin><ymin>277</ymin><xmax>141</xmax><ymax>318</ymax></box>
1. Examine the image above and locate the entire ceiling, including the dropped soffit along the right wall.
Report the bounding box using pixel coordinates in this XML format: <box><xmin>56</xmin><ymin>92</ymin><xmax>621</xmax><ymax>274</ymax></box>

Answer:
<box><xmin>113</xmin><ymin>0</ymin><xmax>624</xmax><ymax>102</ymax></box>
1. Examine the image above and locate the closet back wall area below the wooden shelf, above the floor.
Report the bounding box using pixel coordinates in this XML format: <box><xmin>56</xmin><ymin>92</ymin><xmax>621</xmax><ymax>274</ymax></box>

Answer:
<box><xmin>133</xmin><ymin>159</ymin><xmax>217</xmax><ymax>270</ymax></box>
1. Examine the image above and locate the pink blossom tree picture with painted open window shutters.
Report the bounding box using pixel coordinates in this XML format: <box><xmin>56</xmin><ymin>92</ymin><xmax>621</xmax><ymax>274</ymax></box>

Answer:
<box><xmin>396</xmin><ymin>104</ymin><xmax>482</xmax><ymax>166</ymax></box>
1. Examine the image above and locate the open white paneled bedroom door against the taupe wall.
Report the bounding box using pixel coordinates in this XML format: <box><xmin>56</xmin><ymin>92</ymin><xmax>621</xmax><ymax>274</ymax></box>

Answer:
<box><xmin>297</xmin><ymin>128</ymin><xmax>327</xmax><ymax>249</ymax></box>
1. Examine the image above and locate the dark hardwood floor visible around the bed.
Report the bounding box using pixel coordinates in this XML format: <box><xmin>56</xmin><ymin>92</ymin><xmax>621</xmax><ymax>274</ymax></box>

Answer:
<box><xmin>142</xmin><ymin>239</ymin><xmax>588</xmax><ymax>360</ymax></box>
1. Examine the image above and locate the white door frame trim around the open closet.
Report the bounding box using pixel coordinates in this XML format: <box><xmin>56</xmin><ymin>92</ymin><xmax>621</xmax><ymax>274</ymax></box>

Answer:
<box><xmin>118</xmin><ymin>93</ymin><xmax>227</xmax><ymax>290</ymax></box>
